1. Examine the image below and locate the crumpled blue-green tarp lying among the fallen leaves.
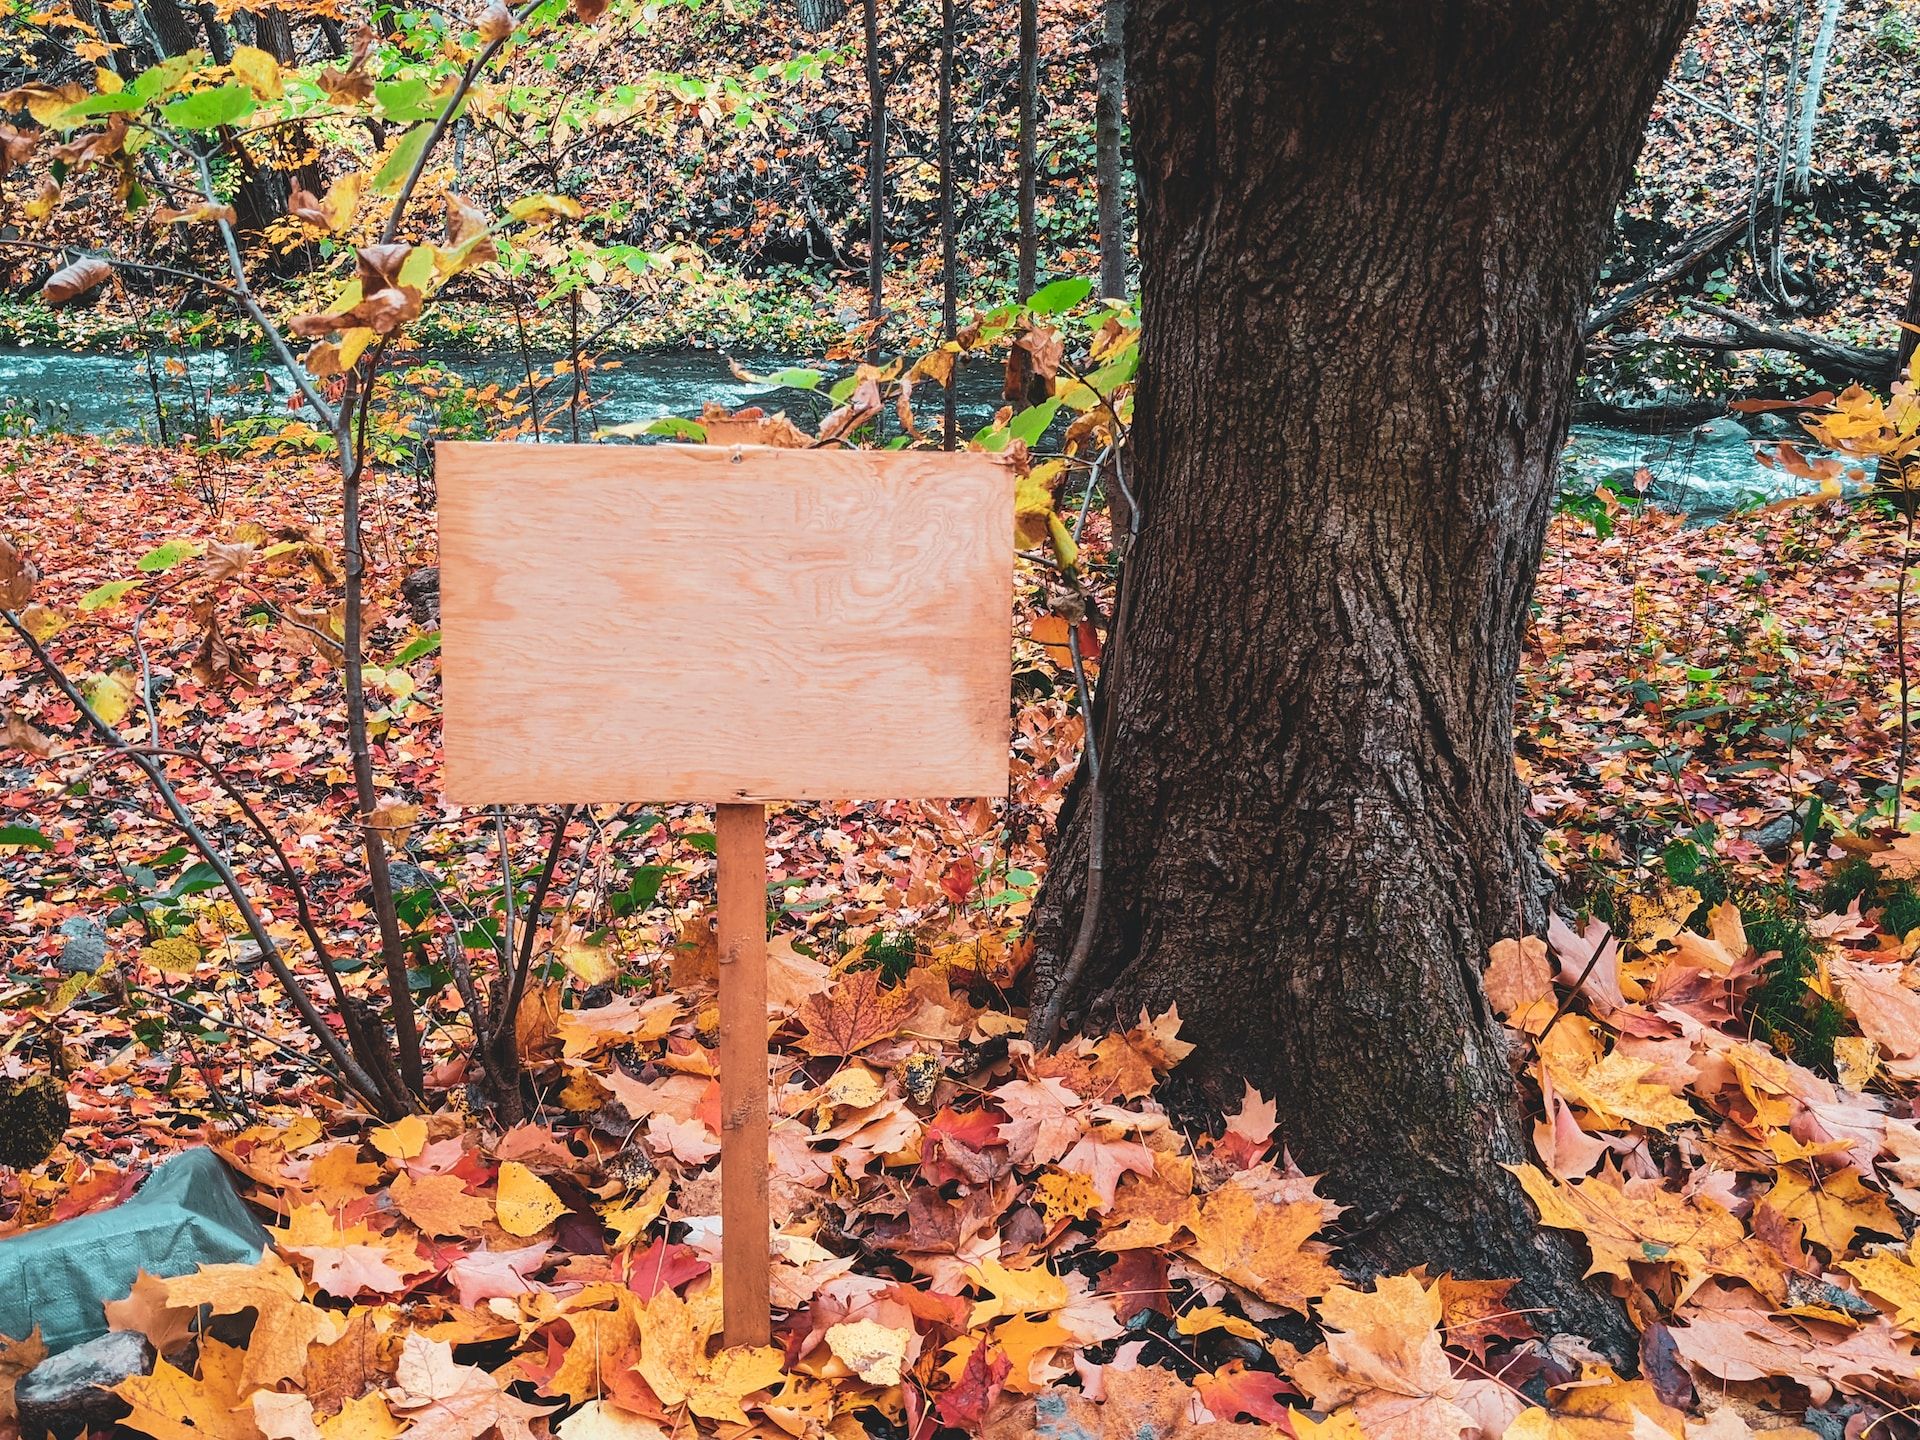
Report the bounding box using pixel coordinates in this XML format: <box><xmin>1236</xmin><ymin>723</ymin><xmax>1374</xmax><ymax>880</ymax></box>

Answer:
<box><xmin>0</xmin><ymin>1146</ymin><xmax>267</xmax><ymax>1354</ymax></box>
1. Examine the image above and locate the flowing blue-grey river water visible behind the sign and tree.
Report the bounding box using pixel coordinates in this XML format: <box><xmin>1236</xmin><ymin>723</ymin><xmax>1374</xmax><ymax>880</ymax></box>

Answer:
<box><xmin>0</xmin><ymin>348</ymin><xmax>1827</xmax><ymax>520</ymax></box>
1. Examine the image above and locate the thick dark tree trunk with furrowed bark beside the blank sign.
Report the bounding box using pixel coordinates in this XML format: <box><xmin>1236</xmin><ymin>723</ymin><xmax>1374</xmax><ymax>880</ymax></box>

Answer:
<box><xmin>1037</xmin><ymin>0</ymin><xmax>1692</xmax><ymax>1348</ymax></box>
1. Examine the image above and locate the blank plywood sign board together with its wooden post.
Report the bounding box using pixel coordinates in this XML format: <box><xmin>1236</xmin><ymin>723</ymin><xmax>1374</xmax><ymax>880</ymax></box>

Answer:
<box><xmin>436</xmin><ymin>444</ymin><xmax>1014</xmax><ymax>1344</ymax></box>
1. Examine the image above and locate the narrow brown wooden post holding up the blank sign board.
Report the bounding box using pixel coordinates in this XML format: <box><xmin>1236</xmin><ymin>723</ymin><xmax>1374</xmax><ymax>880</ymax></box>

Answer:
<box><xmin>714</xmin><ymin>804</ymin><xmax>772</xmax><ymax>1346</ymax></box>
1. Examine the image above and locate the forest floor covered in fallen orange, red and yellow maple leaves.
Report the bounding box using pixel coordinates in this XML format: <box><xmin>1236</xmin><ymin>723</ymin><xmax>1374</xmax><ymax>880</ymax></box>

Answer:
<box><xmin>0</xmin><ymin>440</ymin><xmax>1920</xmax><ymax>1440</ymax></box>
